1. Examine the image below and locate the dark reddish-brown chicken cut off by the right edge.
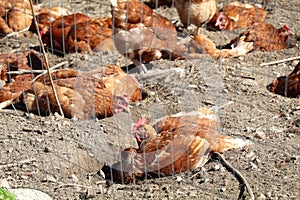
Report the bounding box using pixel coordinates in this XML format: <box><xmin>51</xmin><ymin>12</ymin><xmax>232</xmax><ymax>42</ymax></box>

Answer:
<box><xmin>267</xmin><ymin>62</ymin><xmax>300</xmax><ymax>98</ymax></box>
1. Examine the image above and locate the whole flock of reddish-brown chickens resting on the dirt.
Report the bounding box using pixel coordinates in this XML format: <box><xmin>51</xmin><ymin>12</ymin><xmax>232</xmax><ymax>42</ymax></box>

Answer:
<box><xmin>0</xmin><ymin>0</ymin><xmax>300</xmax><ymax>192</ymax></box>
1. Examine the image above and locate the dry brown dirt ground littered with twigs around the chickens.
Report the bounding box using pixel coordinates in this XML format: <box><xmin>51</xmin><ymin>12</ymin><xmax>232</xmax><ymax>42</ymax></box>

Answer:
<box><xmin>0</xmin><ymin>0</ymin><xmax>300</xmax><ymax>200</ymax></box>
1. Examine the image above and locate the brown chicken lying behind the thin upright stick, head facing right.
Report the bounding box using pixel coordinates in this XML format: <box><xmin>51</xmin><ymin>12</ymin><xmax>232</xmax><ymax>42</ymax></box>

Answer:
<box><xmin>24</xmin><ymin>70</ymin><xmax>129</xmax><ymax>119</ymax></box>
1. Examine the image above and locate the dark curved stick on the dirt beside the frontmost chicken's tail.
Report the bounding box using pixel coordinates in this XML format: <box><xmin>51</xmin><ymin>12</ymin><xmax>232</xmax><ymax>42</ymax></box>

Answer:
<box><xmin>212</xmin><ymin>152</ymin><xmax>254</xmax><ymax>200</ymax></box>
